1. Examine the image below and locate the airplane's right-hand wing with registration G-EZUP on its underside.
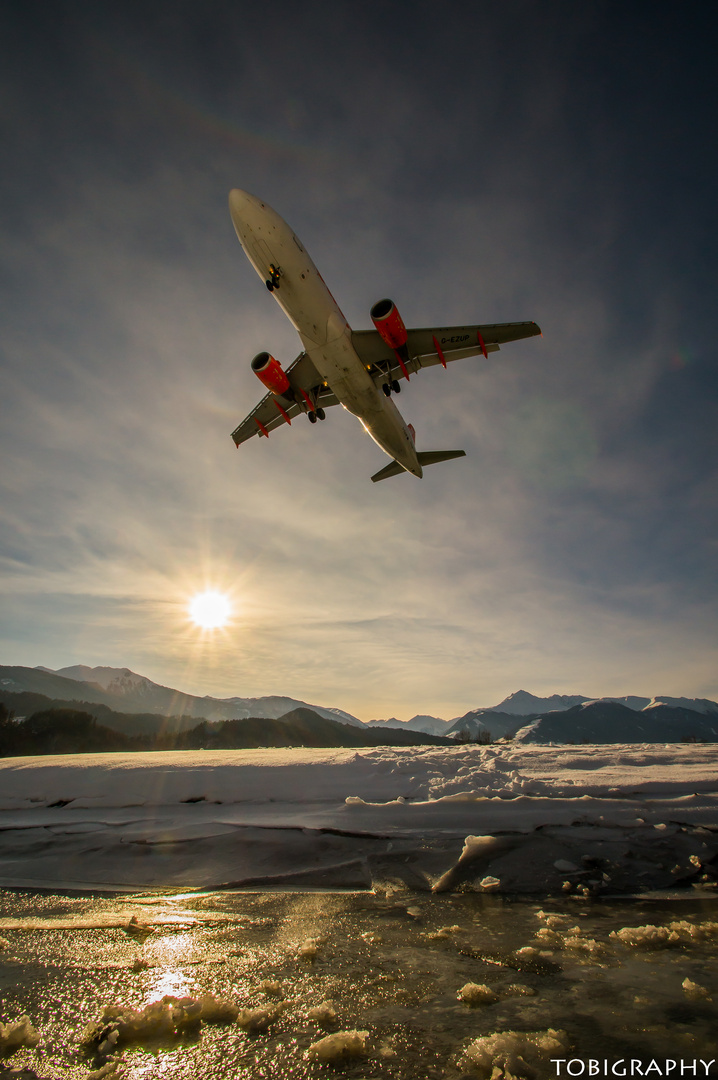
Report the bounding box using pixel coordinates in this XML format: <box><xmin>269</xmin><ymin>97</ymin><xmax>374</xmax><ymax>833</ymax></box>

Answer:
<box><xmin>352</xmin><ymin>323</ymin><xmax>541</xmax><ymax>382</ymax></box>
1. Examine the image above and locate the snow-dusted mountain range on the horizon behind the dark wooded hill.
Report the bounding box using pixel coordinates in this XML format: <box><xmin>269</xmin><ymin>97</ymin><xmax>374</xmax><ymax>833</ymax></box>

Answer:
<box><xmin>0</xmin><ymin>664</ymin><xmax>718</xmax><ymax>742</ymax></box>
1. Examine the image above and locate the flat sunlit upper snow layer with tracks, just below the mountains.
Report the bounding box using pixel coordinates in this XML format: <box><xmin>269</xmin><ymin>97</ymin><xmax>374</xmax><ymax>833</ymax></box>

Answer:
<box><xmin>0</xmin><ymin>744</ymin><xmax>718</xmax><ymax>821</ymax></box>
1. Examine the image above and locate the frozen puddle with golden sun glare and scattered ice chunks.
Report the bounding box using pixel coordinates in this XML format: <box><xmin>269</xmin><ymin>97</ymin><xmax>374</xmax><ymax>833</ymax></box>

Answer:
<box><xmin>0</xmin><ymin>886</ymin><xmax>718</xmax><ymax>1080</ymax></box>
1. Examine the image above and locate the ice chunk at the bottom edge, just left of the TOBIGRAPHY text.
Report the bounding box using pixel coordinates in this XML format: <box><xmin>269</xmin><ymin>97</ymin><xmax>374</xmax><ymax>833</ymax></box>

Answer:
<box><xmin>464</xmin><ymin>1027</ymin><xmax>568</xmax><ymax>1080</ymax></box>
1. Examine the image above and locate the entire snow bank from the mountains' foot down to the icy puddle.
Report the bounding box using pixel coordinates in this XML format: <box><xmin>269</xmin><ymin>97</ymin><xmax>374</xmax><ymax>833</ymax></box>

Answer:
<box><xmin>0</xmin><ymin>744</ymin><xmax>718</xmax><ymax>889</ymax></box>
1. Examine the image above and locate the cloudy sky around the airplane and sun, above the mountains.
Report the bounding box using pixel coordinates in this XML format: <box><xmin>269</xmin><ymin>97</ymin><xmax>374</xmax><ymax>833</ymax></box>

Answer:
<box><xmin>0</xmin><ymin>0</ymin><xmax>718</xmax><ymax>719</ymax></box>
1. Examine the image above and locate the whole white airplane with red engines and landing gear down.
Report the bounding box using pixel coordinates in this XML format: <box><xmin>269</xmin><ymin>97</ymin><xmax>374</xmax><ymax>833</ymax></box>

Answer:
<box><xmin>229</xmin><ymin>188</ymin><xmax>541</xmax><ymax>483</ymax></box>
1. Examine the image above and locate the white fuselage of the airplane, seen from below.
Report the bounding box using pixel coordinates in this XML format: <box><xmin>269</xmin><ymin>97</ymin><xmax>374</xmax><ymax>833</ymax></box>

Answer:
<box><xmin>229</xmin><ymin>188</ymin><xmax>421</xmax><ymax>476</ymax></box>
